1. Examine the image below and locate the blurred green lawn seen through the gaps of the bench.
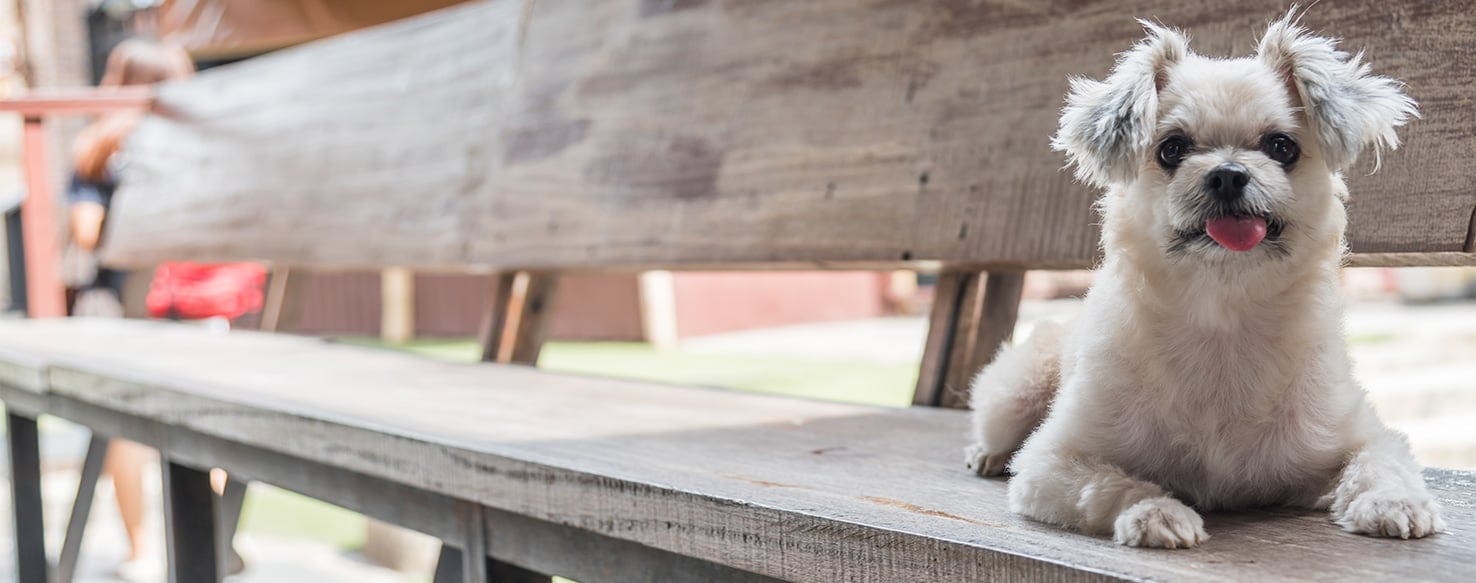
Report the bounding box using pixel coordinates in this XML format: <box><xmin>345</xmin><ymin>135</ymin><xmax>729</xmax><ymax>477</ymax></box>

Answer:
<box><xmin>241</xmin><ymin>338</ymin><xmax>917</xmax><ymax>551</ymax></box>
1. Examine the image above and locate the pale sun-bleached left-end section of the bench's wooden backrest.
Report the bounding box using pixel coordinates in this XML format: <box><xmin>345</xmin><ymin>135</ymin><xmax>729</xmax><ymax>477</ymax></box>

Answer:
<box><xmin>105</xmin><ymin>0</ymin><xmax>523</xmax><ymax>269</ymax></box>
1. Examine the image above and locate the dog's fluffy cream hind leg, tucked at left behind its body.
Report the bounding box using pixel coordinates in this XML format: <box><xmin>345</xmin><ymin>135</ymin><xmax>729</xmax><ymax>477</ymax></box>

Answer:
<box><xmin>967</xmin><ymin>322</ymin><xmax>1064</xmax><ymax>475</ymax></box>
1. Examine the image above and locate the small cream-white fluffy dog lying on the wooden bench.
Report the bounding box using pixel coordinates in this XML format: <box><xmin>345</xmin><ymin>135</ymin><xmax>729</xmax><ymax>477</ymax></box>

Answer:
<box><xmin>968</xmin><ymin>15</ymin><xmax>1444</xmax><ymax>549</ymax></box>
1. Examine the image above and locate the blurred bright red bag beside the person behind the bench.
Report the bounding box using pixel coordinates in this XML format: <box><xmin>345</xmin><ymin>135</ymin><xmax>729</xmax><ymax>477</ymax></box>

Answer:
<box><xmin>146</xmin><ymin>261</ymin><xmax>267</xmax><ymax>320</ymax></box>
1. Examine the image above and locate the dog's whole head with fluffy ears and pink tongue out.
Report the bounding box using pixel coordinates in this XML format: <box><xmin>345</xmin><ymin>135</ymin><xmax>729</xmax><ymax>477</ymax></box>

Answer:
<box><xmin>1052</xmin><ymin>13</ymin><xmax>1418</xmax><ymax>267</ymax></box>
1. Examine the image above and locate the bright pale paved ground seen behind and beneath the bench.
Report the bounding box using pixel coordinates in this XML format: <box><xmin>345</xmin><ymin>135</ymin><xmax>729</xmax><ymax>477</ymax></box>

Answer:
<box><xmin>0</xmin><ymin>301</ymin><xmax>1476</xmax><ymax>583</ymax></box>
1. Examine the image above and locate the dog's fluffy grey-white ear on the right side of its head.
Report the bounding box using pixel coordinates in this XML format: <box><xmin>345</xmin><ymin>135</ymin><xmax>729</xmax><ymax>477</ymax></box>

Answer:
<box><xmin>1256</xmin><ymin>7</ymin><xmax>1420</xmax><ymax>171</ymax></box>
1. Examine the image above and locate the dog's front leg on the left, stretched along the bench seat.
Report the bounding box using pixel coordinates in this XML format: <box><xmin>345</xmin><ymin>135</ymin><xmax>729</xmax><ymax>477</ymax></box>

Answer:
<box><xmin>1010</xmin><ymin>444</ymin><xmax>1209</xmax><ymax>549</ymax></box>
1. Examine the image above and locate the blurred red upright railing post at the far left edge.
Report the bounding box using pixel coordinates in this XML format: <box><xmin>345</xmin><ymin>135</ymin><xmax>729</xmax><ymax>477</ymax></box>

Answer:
<box><xmin>21</xmin><ymin>115</ymin><xmax>66</xmax><ymax>317</ymax></box>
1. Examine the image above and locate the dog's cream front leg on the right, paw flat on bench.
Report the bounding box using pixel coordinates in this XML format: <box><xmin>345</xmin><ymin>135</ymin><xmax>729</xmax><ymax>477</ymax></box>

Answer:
<box><xmin>1328</xmin><ymin>422</ymin><xmax>1445</xmax><ymax>539</ymax></box>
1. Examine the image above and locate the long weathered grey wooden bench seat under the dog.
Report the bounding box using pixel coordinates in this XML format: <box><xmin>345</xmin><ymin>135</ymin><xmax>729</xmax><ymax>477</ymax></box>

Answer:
<box><xmin>0</xmin><ymin>319</ymin><xmax>1476</xmax><ymax>582</ymax></box>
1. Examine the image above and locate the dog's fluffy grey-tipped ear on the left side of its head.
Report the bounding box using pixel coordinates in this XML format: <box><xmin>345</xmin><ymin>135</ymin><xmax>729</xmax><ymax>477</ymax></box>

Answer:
<box><xmin>1051</xmin><ymin>21</ymin><xmax>1190</xmax><ymax>187</ymax></box>
